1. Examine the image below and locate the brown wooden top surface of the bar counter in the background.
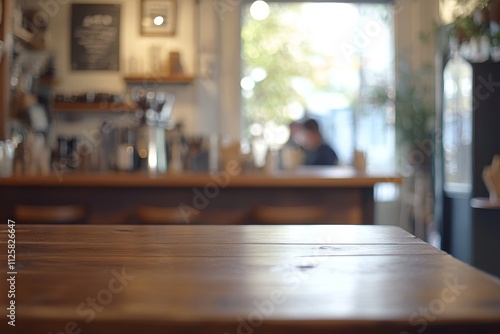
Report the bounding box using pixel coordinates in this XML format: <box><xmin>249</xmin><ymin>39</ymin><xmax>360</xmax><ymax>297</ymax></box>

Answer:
<box><xmin>0</xmin><ymin>167</ymin><xmax>403</xmax><ymax>188</ymax></box>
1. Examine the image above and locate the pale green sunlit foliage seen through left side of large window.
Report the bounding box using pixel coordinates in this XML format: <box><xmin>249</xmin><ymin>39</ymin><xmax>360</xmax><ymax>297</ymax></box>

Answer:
<box><xmin>241</xmin><ymin>4</ymin><xmax>312</xmax><ymax>128</ymax></box>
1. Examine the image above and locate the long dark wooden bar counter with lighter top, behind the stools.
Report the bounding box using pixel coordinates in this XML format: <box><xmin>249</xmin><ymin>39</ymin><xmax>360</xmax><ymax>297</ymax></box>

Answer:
<box><xmin>0</xmin><ymin>165</ymin><xmax>403</xmax><ymax>224</ymax></box>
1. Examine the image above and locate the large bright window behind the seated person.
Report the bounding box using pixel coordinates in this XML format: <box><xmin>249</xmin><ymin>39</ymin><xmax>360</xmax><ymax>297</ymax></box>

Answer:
<box><xmin>241</xmin><ymin>1</ymin><xmax>395</xmax><ymax>171</ymax></box>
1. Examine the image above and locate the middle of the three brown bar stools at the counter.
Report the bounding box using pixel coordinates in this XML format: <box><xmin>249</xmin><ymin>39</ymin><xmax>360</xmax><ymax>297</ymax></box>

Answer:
<box><xmin>136</xmin><ymin>205</ymin><xmax>198</xmax><ymax>225</ymax></box>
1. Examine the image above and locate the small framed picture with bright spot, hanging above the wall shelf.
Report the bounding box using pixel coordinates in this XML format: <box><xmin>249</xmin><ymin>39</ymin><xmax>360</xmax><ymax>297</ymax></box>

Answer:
<box><xmin>141</xmin><ymin>0</ymin><xmax>177</xmax><ymax>36</ymax></box>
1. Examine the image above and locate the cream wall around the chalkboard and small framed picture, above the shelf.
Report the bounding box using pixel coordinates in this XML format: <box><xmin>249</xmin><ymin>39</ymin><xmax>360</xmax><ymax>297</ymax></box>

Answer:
<box><xmin>48</xmin><ymin>0</ymin><xmax>195</xmax><ymax>88</ymax></box>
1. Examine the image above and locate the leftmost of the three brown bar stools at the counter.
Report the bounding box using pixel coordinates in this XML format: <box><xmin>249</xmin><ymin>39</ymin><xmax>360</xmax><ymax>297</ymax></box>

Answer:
<box><xmin>14</xmin><ymin>205</ymin><xmax>87</xmax><ymax>224</ymax></box>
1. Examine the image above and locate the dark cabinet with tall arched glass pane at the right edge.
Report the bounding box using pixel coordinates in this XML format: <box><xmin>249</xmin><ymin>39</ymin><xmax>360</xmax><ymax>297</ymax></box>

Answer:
<box><xmin>436</xmin><ymin>57</ymin><xmax>500</xmax><ymax>272</ymax></box>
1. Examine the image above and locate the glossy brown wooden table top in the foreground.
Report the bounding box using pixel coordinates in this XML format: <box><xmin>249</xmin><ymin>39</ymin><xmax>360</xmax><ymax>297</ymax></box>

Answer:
<box><xmin>0</xmin><ymin>224</ymin><xmax>500</xmax><ymax>334</ymax></box>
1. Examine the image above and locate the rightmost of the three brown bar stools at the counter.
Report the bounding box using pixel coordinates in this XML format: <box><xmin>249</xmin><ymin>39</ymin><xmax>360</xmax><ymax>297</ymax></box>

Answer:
<box><xmin>252</xmin><ymin>206</ymin><xmax>328</xmax><ymax>224</ymax></box>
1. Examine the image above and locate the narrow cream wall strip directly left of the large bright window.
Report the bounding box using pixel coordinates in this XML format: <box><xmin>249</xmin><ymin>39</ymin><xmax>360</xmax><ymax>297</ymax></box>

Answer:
<box><xmin>195</xmin><ymin>0</ymin><xmax>241</xmax><ymax>140</ymax></box>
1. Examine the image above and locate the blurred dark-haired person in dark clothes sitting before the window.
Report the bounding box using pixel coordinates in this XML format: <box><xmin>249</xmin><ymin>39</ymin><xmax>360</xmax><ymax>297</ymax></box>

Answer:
<box><xmin>302</xmin><ymin>119</ymin><xmax>339</xmax><ymax>166</ymax></box>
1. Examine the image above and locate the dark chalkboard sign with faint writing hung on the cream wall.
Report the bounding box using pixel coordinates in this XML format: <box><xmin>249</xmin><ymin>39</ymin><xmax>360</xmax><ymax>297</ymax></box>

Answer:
<box><xmin>71</xmin><ymin>4</ymin><xmax>120</xmax><ymax>71</ymax></box>
